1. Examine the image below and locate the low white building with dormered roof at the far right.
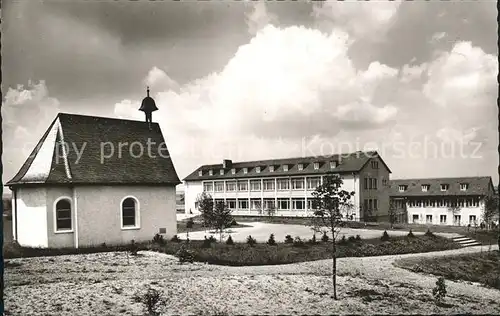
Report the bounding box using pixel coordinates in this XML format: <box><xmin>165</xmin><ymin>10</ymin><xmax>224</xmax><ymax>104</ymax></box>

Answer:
<box><xmin>390</xmin><ymin>177</ymin><xmax>495</xmax><ymax>226</ymax></box>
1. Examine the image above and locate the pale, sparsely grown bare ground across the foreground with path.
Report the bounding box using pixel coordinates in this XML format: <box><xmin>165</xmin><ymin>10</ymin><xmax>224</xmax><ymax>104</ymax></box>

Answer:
<box><xmin>4</xmin><ymin>247</ymin><xmax>500</xmax><ymax>316</ymax></box>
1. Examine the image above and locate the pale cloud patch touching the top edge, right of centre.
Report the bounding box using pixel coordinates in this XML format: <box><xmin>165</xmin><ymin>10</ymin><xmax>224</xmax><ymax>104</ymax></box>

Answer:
<box><xmin>313</xmin><ymin>0</ymin><xmax>401</xmax><ymax>41</ymax></box>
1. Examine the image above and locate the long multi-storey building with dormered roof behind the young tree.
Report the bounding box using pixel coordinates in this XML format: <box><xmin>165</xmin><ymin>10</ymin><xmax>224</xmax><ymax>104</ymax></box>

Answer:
<box><xmin>184</xmin><ymin>151</ymin><xmax>391</xmax><ymax>220</ymax></box>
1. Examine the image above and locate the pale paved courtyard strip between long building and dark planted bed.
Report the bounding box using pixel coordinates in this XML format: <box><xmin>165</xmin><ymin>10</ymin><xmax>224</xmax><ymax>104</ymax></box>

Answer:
<box><xmin>178</xmin><ymin>222</ymin><xmax>459</xmax><ymax>242</ymax></box>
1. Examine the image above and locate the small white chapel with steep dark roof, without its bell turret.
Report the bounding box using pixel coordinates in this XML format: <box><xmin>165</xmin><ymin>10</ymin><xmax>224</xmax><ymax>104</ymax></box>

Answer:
<box><xmin>7</xmin><ymin>113</ymin><xmax>180</xmax><ymax>248</ymax></box>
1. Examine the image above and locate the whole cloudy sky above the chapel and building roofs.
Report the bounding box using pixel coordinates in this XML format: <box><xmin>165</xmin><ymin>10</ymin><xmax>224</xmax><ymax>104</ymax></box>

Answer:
<box><xmin>2</xmin><ymin>0</ymin><xmax>499</xmax><ymax>191</ymax></box>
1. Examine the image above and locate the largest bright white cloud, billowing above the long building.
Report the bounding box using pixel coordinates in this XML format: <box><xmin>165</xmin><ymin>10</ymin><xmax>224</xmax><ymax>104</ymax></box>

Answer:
<box><xmin>117</xmin><ymin>25</ymin><xmax>398</xmax><ymax>144</ymax></box>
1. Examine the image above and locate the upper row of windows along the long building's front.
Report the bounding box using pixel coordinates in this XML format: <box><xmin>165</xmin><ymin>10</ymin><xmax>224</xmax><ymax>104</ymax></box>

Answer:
<box><xmin>203</xmin><ymin>177</ymin><xmax>321</xmax><ymax>192</ymax></box>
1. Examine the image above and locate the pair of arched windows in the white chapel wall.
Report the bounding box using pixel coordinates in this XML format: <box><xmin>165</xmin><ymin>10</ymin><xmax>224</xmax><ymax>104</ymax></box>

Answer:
<box><xmin>54</xmin><ymin>197</ymin><xmax>139</xmax><ymax>232</ymax></box>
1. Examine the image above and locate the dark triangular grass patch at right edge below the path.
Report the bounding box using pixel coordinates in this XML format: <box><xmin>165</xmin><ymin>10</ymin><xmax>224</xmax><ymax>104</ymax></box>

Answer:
<box><xmin>395</xmin><ymin>251</ymin><xmax>500</xmax><ymax>290</ymax></box>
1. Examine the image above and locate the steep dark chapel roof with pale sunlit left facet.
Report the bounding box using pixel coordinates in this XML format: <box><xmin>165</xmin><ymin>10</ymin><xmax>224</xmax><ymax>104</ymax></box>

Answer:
<box><xmin>6</xmin><ymin>113</ymin><xmax>180</xmax><ymax>186</ymax></box>
